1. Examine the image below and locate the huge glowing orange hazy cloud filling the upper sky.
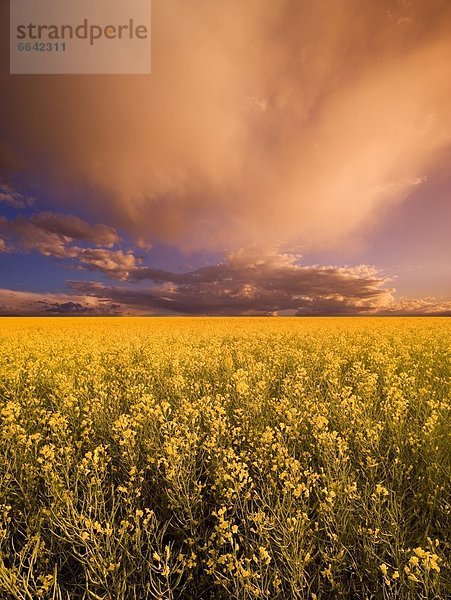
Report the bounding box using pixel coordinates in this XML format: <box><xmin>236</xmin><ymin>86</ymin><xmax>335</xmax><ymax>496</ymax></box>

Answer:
<box><xmin>0</xmin><ymin>0</ymin><xmax>451</xmax><ymax>251</ymax></box>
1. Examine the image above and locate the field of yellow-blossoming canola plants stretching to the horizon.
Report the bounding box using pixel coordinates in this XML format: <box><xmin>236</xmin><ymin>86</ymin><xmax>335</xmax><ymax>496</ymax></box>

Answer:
<box><xmin>0</xmin><ymin>317</ymin><xmax>451</xmax><ymax>600</ymax></box>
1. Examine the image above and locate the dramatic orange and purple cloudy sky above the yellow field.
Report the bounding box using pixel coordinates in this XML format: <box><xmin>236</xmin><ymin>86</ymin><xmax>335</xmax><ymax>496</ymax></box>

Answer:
<box><xmin>0</xmin><ymin>0</ymin><xmax>451</xmax><ymax>316</ymax></box>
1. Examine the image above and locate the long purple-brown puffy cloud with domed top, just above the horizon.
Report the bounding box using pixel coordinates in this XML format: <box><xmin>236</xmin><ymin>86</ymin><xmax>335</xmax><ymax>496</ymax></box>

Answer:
<box><xmin>69</xmin><ymin>249</ymin><xmax>393</xmax><ymax>315</ymax></box>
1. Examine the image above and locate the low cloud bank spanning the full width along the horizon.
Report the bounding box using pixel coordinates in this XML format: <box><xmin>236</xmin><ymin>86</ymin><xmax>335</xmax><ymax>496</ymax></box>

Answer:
<box><xmin>0</xmin><ymin>248</ymin><xmax>451</xmax><ymax>316</ymax></box>
